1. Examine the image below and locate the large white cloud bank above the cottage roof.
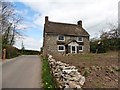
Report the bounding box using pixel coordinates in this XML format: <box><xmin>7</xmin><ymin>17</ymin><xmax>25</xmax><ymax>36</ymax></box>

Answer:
<box><xmin>20</xmin><ymin>0</ymin><xmax>118</xmax><ymax>33</ymax></box>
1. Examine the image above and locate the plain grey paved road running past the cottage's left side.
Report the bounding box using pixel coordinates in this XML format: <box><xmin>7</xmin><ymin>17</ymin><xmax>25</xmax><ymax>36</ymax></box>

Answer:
<box><xmin>2</xmin><ymin>55</ymin><xmax>42</xmax><ymax>88</ymax></box>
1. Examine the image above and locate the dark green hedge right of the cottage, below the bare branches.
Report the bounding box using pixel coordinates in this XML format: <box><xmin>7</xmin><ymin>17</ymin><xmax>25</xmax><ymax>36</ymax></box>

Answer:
<box><xmin>90</xmin><ymin>38</ymin><xmax>120</xmax><ymax>53</ymax></box>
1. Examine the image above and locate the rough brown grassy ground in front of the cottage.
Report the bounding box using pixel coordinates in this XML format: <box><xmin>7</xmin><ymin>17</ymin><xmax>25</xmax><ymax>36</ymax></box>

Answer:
<box><xmin>53</xmin><ymin>51</ymin><xmax>120</xmax><ymax>88</ymax></box>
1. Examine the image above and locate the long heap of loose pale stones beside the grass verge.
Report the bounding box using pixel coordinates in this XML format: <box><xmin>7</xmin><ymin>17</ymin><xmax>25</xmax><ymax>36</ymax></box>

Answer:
<box><xmin>48</xmin><ymin>55</ymin><xmax>85</xmax><ymax>88</ymax></box>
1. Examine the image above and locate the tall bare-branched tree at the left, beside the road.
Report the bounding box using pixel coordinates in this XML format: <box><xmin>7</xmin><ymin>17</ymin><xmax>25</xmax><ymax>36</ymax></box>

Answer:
<box><xmin>0</xmin><ymin>2</ymin><xmax>22</xmax><ymax>46</ymax></box>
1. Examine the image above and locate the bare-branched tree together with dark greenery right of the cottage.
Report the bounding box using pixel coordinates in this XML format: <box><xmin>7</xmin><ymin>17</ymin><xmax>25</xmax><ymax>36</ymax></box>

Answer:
<box><xmin>90</xmin><ymin>23</ymin><xmax>120</xmax><ymax>53</ymax></box>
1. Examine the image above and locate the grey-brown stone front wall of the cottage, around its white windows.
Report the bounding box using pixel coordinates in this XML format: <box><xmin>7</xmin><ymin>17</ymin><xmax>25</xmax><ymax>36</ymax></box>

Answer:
<box><xmin>45</xmin><ymin>34</ymin><xmax>90</xmax><ymax>54</ymax></box>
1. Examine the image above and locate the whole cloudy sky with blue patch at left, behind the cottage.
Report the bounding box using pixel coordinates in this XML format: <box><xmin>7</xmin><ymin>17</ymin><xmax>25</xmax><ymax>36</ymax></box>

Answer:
<box><xmin>3</xmin><ymin>0</ymin><xmax>119</xmax><ymax>51</ymax></box>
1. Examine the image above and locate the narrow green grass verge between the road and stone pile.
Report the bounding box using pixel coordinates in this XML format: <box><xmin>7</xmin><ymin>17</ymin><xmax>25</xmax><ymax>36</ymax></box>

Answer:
<box><xmin>42</xmin><ymin>58</ymin><xmax>56</xmax><ymax>90</ymax></box>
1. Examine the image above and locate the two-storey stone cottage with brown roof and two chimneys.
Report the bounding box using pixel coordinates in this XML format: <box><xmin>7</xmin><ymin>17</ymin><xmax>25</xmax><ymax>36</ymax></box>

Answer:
<box><xmin>43</xmin><ymin>16</ymin><xmax>90</xmax><ymax>55</ymax></box>
